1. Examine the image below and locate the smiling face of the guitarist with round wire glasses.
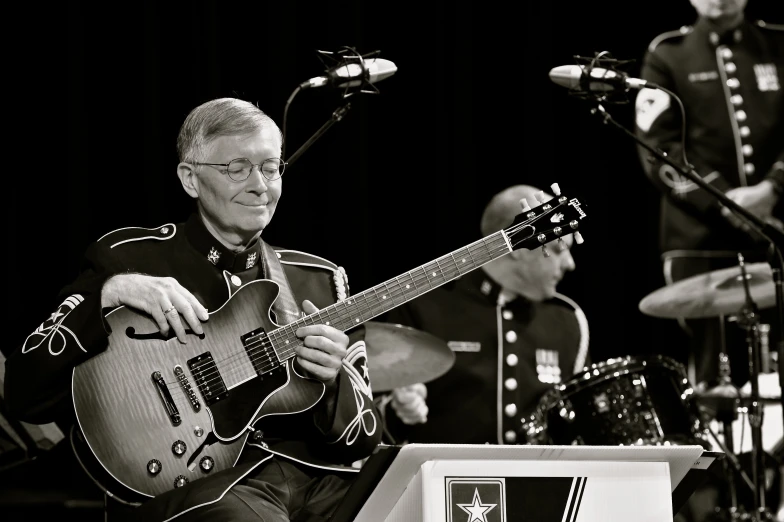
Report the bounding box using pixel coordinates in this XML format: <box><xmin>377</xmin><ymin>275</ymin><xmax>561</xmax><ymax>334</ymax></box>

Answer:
<box><xmin>179</xmin><ymin>125</ymin><xmax>283</xmax><ymax>249</ymax></box>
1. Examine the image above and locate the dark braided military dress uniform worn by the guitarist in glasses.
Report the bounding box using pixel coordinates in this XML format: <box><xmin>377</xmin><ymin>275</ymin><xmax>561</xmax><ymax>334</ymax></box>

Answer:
<box><xmin>5</xmin><ymin>214</ymin><xmax>381</xmax><ymax>520</ymax></box>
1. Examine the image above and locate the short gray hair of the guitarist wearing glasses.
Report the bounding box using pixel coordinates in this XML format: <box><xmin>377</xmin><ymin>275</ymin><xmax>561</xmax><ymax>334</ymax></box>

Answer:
<box><xmin>177</xmin><ymin>98</ymin><xmax>283</xmax><ymax>162</ymax></box>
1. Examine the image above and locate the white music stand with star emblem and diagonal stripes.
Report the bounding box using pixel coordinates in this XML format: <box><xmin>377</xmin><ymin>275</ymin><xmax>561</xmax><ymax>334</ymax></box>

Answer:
<box><xmin>342</xmin><ymin>444</ymin><xmax>714</xmax><ymax>522</ymax></box>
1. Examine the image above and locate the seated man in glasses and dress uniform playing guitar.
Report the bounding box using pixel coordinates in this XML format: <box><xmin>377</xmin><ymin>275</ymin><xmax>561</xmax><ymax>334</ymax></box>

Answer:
<box><xmin>5</xmin><ymin>98</ymin><xmax>381</xmax><ymax>522</ymax></box>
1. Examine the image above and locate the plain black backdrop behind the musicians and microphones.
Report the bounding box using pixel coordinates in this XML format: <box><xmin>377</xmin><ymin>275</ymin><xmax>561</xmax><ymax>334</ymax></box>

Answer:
<box><xmin>9</xmin><ymin>0</ymin><xmax>784</xmax><ymax>361</ymax></box>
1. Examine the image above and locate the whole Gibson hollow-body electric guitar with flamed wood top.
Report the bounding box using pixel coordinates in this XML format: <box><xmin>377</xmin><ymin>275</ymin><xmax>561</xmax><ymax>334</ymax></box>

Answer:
<box><xmin>72</xmin><ymin>184</ymin><xmax>586</xmax><ymax>496</ymax></box>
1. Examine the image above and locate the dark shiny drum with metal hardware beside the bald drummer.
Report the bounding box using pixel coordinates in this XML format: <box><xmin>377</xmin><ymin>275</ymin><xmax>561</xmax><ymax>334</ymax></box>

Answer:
<box><xmin>522</xmin><ymin>355</ymin><xmax>710</xmax><ymax>449</ymax></box>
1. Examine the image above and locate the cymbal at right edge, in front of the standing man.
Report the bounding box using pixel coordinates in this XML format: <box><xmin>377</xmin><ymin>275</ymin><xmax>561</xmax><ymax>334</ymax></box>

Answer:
<box><xmin>639</xmin><ymin>263</ymin><xmax>776</xmax><ymax>319</ymax></box>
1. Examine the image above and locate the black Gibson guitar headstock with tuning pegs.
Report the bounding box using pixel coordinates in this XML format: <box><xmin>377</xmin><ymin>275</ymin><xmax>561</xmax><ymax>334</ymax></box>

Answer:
<box><xmin>504</xmin><ymin>183</ymin><xmax>587</xmax><ymax>256</ymax></box>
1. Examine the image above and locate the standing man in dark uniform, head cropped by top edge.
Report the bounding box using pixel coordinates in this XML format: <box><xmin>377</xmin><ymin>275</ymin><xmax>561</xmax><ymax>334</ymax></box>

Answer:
<box><xmin>636</xmin><ymin>0</ymin><xmax>784</xmax><ymax>387</ymax></box>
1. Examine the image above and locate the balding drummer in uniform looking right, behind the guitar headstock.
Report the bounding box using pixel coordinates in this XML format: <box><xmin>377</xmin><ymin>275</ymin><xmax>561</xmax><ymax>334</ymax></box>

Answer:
<box><xmin>380</xmin><ymin>185</ymin><xmax>588</xmax><ymax>444</ymax></box>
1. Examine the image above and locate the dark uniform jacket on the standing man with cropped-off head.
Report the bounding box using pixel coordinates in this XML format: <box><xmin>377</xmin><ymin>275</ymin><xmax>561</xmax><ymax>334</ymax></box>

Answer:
<box><xmin>635</xmin><ymin>19</ymin><xmax>784</xmax><ymax>252</ymax></box>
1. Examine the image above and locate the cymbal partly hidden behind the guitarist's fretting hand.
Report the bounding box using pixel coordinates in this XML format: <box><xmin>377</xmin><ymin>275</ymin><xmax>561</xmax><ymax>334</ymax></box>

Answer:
<box><xmin>365</xmin><ymin>321</ymin><xmax>455</xmax><ymax>392</ymax></box>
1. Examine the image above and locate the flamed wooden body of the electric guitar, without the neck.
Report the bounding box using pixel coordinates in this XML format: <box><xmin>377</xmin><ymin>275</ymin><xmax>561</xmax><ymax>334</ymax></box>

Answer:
<box><xmin>72</xmin><ymin>281</ymin><xmax>324</xmax><ymax>496</ymax></box>
